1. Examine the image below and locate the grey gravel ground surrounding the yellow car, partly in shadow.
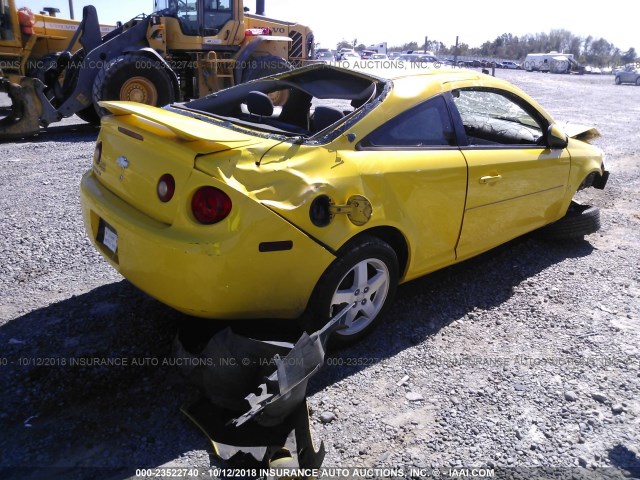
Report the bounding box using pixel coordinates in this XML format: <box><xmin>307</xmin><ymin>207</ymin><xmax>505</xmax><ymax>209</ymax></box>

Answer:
<box><xmin>0</xmin><ymin>71</ymin><xmax>640</xmax><ymax>479</ymax></box>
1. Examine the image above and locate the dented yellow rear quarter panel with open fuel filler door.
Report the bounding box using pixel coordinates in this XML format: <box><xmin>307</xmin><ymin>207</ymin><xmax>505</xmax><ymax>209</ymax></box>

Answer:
<box><xmin>196</xmin><ymin>78</ymin><xmax>467</xmax><ymax>281</ymax></box>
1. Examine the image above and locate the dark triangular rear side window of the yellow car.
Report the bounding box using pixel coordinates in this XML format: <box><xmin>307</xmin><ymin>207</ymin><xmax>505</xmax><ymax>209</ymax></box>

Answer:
<box><xmin>360</xmin><ymin>96</ymin><xmax>456</xmax><ymax>148</ymax></box>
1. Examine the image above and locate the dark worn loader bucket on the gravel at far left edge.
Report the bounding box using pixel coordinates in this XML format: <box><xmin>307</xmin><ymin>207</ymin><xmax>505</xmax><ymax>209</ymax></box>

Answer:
<box><xmin>0</xmin><ymin>77</ymin><xmax>45</xmax><ymax>141</ymax></box>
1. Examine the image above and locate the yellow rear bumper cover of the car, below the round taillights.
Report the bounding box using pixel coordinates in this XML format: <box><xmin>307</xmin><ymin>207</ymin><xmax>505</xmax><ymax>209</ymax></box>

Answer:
<box><xmin>81</xmin><ymin>171</ymin><xmax>335</xmax><ymax>319</ymax></box>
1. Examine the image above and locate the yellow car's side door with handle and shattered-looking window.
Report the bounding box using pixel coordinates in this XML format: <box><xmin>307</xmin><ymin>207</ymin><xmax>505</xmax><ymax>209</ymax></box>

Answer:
<box><xmin>452</xmin><ymin>88</ymin><xmax>570</xmax><ymax>259</ymax></box>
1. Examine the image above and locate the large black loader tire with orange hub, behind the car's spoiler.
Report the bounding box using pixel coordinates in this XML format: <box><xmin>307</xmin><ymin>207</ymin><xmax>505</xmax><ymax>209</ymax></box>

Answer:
<box><xmin>93</xmin><ymin>53</ymin><xmax>176</xmax><ymax>117</ymax></box>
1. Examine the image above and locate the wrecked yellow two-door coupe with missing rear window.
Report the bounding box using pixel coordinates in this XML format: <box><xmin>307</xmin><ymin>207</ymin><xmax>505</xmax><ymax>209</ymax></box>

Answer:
<box><xmin>81</xmin><ymin>65</ymin><xmax>608</xmax><ymax>345</ymax></box>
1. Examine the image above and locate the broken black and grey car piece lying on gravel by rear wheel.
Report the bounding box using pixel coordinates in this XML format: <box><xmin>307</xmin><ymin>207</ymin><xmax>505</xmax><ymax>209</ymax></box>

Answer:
<box><xmin>176</xmin><ymin>305</ymin><xmax>351</xmax><ymax>469</ymax></box>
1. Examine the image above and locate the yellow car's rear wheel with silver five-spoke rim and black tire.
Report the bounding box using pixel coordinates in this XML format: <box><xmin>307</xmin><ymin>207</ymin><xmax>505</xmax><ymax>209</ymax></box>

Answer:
<box><xmin>303</xmin><ymin>237</ymin><xmax>399</xmax><ymax>347</ymax></box>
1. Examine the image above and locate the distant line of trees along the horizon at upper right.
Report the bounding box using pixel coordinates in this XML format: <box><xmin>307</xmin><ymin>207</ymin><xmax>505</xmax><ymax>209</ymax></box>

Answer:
<box><xmin>337</xmin><ymin>29</ymin><xmax>638</xmax><ymax>67</ymax></box>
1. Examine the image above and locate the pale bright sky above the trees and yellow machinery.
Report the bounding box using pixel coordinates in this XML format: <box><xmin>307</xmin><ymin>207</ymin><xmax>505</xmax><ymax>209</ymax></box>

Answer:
<box><xmin>22</xmin><ymin>0</ymin><xmax>640</xmax><ymax>51</ymax></box>
